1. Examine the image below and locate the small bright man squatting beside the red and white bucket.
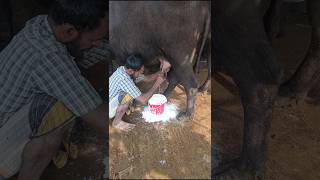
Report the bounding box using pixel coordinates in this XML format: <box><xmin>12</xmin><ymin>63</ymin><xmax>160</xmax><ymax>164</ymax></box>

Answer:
<box><xmin>109</xmin><ymin>54</ymin><xmax>171</xmax><ymax>131</ymax></box>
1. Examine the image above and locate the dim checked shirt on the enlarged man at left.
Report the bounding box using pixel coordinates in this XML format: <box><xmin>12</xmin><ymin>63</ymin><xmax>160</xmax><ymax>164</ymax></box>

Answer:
<box><xmin>0</xmin><ymin>15</ymin><xmax>102</xmax><ymax>127</ymax></box>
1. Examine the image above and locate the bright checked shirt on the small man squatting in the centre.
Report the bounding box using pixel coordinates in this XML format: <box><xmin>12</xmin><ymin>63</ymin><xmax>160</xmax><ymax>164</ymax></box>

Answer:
<box><xmin>109</xmin><ymin>66</ymin><xmax>141</xmax><ymax>100</ymax></box>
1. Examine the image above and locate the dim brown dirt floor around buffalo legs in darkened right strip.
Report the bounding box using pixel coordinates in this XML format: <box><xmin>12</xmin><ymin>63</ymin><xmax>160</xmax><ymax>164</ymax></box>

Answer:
<box><xmin>212</xmin><ymin>1</ymin><xmax>320</xmax><ymax>180</ymax></box>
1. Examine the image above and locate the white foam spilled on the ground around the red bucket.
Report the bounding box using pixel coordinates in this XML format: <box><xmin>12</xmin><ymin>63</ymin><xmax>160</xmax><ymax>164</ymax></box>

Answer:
<box><xmin>142</xmin><ymin>103</ymin><xmax>178</xmax><ymax>123</ymax></box>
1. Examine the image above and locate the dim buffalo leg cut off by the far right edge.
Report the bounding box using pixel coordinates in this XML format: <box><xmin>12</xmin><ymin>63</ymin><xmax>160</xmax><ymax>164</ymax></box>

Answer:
<box><xmin>279</xmin><ymin>0</ymin><xmax>320</xmax><ymax>102</ymax></box>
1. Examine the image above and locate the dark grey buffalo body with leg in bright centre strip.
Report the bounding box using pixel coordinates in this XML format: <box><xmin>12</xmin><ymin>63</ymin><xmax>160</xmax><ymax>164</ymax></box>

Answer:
<box><xmin>109</xmin><ymin>1</ymin><xmax>209</xmax><ymax>117</ymax></box>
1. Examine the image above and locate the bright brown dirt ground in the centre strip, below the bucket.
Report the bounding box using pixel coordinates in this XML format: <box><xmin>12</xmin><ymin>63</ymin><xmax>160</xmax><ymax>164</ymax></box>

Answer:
<box><xmin>109</xmin><ymin>70</ymin><xmax>211</xmax><ymax>179</ymax></box>
